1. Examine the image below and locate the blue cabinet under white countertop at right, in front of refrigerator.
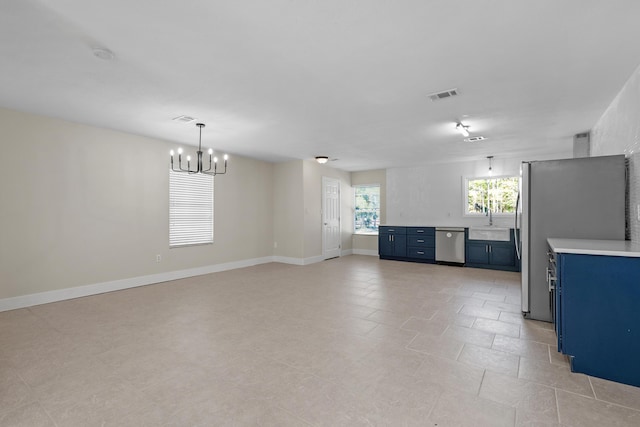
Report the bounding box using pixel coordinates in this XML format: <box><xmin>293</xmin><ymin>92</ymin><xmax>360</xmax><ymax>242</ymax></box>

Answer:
<box><xmin>554</xmin><ymin>253</ymin><xmax>640</xmax><ymax>387</ymax></box>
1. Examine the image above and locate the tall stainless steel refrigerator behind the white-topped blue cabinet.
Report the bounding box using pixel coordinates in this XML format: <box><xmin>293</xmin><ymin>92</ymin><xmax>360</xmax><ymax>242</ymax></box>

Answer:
<box><xmin>516</xmin><ymin>155</ymin><xmax>626</xmax><ymax>322</ymax></box>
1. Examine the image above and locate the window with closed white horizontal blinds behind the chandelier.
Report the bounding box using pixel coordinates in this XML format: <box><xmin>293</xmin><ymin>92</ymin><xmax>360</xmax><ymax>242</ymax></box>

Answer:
<box><xmin>169</xmin><ymin>170</ymin><xmax>213</xmax><ymax>248</ymax></box>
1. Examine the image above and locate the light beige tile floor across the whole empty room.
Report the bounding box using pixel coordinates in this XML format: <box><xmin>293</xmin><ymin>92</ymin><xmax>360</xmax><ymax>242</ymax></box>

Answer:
<box><xmin>0</xmin><ymin>256</ymin><xmax>640</xmax><ymax>427</ymax></box>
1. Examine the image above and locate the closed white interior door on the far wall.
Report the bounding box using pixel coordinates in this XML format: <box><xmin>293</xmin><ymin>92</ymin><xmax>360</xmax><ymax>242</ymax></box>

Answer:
<box><xmin>322</xmin><ymin>176</ymin><xmax>341</xmax><ymax>259</ymax></box>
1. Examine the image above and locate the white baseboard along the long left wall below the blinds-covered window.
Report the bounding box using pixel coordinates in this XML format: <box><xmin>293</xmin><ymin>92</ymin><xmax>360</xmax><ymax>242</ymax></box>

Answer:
<box><xmin>0</xmin><ymin>256</ymin><xmax>274</xmax><ymax>312</ymax></box>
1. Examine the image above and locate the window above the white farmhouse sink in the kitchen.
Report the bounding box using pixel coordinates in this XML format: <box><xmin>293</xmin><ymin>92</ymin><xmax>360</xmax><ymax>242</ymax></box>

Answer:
<box><xmin>465</xmin><ymin>176</ymin><xmax>519</xmax><ymax>215</ymax></box>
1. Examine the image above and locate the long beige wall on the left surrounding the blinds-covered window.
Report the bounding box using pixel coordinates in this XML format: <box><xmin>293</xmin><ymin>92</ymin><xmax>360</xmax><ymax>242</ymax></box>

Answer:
<box><xmin>0</xmin><ymin>109</ymin><xmax>274</xmax><ymax>299</ymax></box>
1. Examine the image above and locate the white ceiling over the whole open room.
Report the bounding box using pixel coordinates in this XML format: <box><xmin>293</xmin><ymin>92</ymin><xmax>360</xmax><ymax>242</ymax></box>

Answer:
<box><xmin>0</xmin><ymin>0</ymin><xmax>640</xmax><ymax>171</ymax></box>
